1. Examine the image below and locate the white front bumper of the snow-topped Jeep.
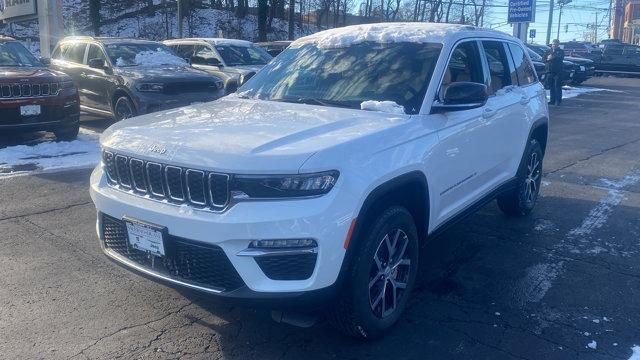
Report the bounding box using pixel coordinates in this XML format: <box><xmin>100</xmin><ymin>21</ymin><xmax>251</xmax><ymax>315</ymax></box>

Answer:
<box><xmin>91</xmin><ymin>166</ymin><xmax>353</xmax><ymax>299</ymax></box>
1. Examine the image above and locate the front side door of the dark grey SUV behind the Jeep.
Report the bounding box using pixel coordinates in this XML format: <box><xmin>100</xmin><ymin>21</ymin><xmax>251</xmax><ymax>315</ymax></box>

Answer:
<box><xmin>79</xmin><ymin>43</ymin><xmax>112</xmax><ymax>111</ymax></box>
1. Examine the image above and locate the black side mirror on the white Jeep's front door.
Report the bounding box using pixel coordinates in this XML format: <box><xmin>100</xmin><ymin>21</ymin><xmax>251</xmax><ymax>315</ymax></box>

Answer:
<box><xmin>431</xmin><ymin>81</ymin><xmax>489</xmax><ymax>113</ymax></box>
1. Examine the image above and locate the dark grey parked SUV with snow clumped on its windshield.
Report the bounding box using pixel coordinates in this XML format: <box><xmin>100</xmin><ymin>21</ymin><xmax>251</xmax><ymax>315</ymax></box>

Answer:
<box><xmin>50</xmin><ymin>36</ymin><xmax>224</xmax><ymax>120</ymax></box>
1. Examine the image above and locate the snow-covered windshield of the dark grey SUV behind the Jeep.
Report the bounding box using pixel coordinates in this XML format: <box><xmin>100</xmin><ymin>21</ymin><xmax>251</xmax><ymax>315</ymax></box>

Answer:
<box><xmin>105</xmin><ymin>43</ymin><xmax>187</xmax><ymax>67</ymax></box>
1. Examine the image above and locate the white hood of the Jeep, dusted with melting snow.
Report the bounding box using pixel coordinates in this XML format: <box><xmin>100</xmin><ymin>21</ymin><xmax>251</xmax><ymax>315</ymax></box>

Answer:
<box><xmin>101</xmin><ymin>96</ymin><xmax>410</xmax><ymax>174</ymax></box>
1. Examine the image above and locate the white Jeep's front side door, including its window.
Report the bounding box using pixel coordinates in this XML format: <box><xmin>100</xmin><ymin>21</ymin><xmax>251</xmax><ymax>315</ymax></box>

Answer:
<box><xmin>426</xmin><ymin>40</ymin><xmax>499</xmax><ymax>225</ymax></box>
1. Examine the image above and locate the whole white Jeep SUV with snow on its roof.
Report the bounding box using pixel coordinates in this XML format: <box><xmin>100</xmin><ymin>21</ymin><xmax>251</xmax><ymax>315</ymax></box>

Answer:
<box><xmin>91</xmin><ymin>23</ymin><xmax>548</xmax><ymax>338</ymax></box>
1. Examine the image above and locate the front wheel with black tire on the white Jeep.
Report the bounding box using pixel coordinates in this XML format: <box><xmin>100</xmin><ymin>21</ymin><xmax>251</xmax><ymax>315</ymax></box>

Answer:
<box><xmin>328</xmin><ymin>206</ymin><xmax>418</xmax><ymax>339</ymax></box>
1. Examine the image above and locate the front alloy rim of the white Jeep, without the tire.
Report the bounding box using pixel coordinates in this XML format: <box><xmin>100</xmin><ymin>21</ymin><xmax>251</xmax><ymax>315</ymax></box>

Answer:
<box><xmin>369</xmin><ymin>228</ymin><xmax>411</xmax><ymax>319</ymax></box>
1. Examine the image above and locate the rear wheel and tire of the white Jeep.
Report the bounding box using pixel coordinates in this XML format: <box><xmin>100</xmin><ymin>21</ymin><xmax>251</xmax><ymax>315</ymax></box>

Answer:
<box><xmin>498</xmin><ymin>139</ymin><xmax>543</xmax><ymax>216</ymax></box>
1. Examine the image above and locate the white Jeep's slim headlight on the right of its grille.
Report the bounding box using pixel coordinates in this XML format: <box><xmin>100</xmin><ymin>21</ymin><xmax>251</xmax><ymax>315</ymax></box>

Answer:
<box><xmin>231</xmin><ymin>170</ymin><xmax>339</xmax><ymax>199</ymax></box>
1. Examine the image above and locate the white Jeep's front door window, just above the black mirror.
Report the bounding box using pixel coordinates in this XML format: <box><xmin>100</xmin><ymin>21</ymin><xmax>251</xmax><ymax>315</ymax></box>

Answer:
<box><xmin>440</xmin><ymin>41</ymin><xmax>484</xmax><ymax>95</ymax></box>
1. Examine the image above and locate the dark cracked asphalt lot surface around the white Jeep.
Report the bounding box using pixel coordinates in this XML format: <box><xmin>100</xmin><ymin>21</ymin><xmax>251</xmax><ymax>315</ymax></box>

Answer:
<box><xmin>0</xmin><ymin>78</ymin><xmax>640</xmax><ymax>360</ymax></box>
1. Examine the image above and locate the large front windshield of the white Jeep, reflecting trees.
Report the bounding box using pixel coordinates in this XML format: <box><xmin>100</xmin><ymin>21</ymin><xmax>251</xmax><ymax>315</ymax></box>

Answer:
<box><xmin>239</xmin><ymin>42</ymin><xmax>442</xmax><ymax>114</ymax></box>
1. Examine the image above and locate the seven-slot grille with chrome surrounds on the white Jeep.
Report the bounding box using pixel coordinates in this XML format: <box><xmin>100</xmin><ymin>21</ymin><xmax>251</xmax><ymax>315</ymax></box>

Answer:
<box><xmin>102</xmin><ymin>151</ymin><xmax>229</xmax><ymax>211</ymax></box>
